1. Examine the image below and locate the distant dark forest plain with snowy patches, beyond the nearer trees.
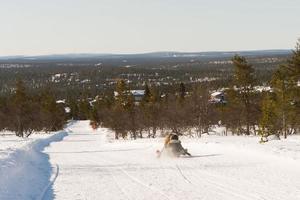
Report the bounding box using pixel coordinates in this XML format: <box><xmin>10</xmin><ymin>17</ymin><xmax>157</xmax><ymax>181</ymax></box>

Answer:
<box><xmin>0</xmin><ymin>54</ymin><xmax>289</xmax><ymax>99</ymax></box>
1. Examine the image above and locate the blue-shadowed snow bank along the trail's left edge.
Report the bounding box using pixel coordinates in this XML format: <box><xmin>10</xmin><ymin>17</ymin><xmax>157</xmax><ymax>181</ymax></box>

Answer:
<box><xmin>0</xmin><ymin>131</ymin><xmax>68</xmax><ymax>200</ymax></box>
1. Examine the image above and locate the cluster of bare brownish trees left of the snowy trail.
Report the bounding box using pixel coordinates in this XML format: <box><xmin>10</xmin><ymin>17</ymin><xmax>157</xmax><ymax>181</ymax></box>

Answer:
<box><xmin>0</xmin><ymin>80</ymin><xmax>66</xmax><ymax>137</ymax></box>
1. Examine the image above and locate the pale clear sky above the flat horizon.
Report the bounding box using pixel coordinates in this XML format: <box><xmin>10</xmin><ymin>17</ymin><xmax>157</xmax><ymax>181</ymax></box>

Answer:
<box><xmin>0</xmin><ymin>0</ymin><xmax>300</xmax><ymax>56</ymax></box>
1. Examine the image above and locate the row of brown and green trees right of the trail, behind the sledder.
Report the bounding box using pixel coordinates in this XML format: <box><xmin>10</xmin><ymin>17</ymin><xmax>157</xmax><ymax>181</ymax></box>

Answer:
<box><xmin>89</xmin><ymin>40</ymin><xmax>300</xmax><ymax>139</ymax></box>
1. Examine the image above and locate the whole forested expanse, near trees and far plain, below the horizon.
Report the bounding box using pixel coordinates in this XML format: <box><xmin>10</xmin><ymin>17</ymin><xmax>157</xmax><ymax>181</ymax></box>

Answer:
<box><xmin>0</xmin><ymin>46</ymin><xmax>300</xmax><ymax>142</ymax></box>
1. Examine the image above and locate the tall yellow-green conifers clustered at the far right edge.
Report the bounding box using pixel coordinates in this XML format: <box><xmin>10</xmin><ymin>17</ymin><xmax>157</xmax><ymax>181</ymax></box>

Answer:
<box><xmin>260</xmin><ymin>39</ymin><xmax>300</xmax><ymax>138</ymax></box>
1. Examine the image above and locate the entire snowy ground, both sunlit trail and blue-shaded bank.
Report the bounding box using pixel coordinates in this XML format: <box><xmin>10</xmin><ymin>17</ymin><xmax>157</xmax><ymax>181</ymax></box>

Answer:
<box><xmin>0</xmin><ymin>121</ymin><xmax>300</xmax><ymax>200</ymax></box>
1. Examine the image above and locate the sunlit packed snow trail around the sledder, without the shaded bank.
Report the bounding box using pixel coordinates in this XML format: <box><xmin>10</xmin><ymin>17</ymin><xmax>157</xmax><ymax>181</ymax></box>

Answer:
<box><xmin>44</xmin><ymin>121</ymin><xmax>300</xmax><ymax>200</ymax></box>
